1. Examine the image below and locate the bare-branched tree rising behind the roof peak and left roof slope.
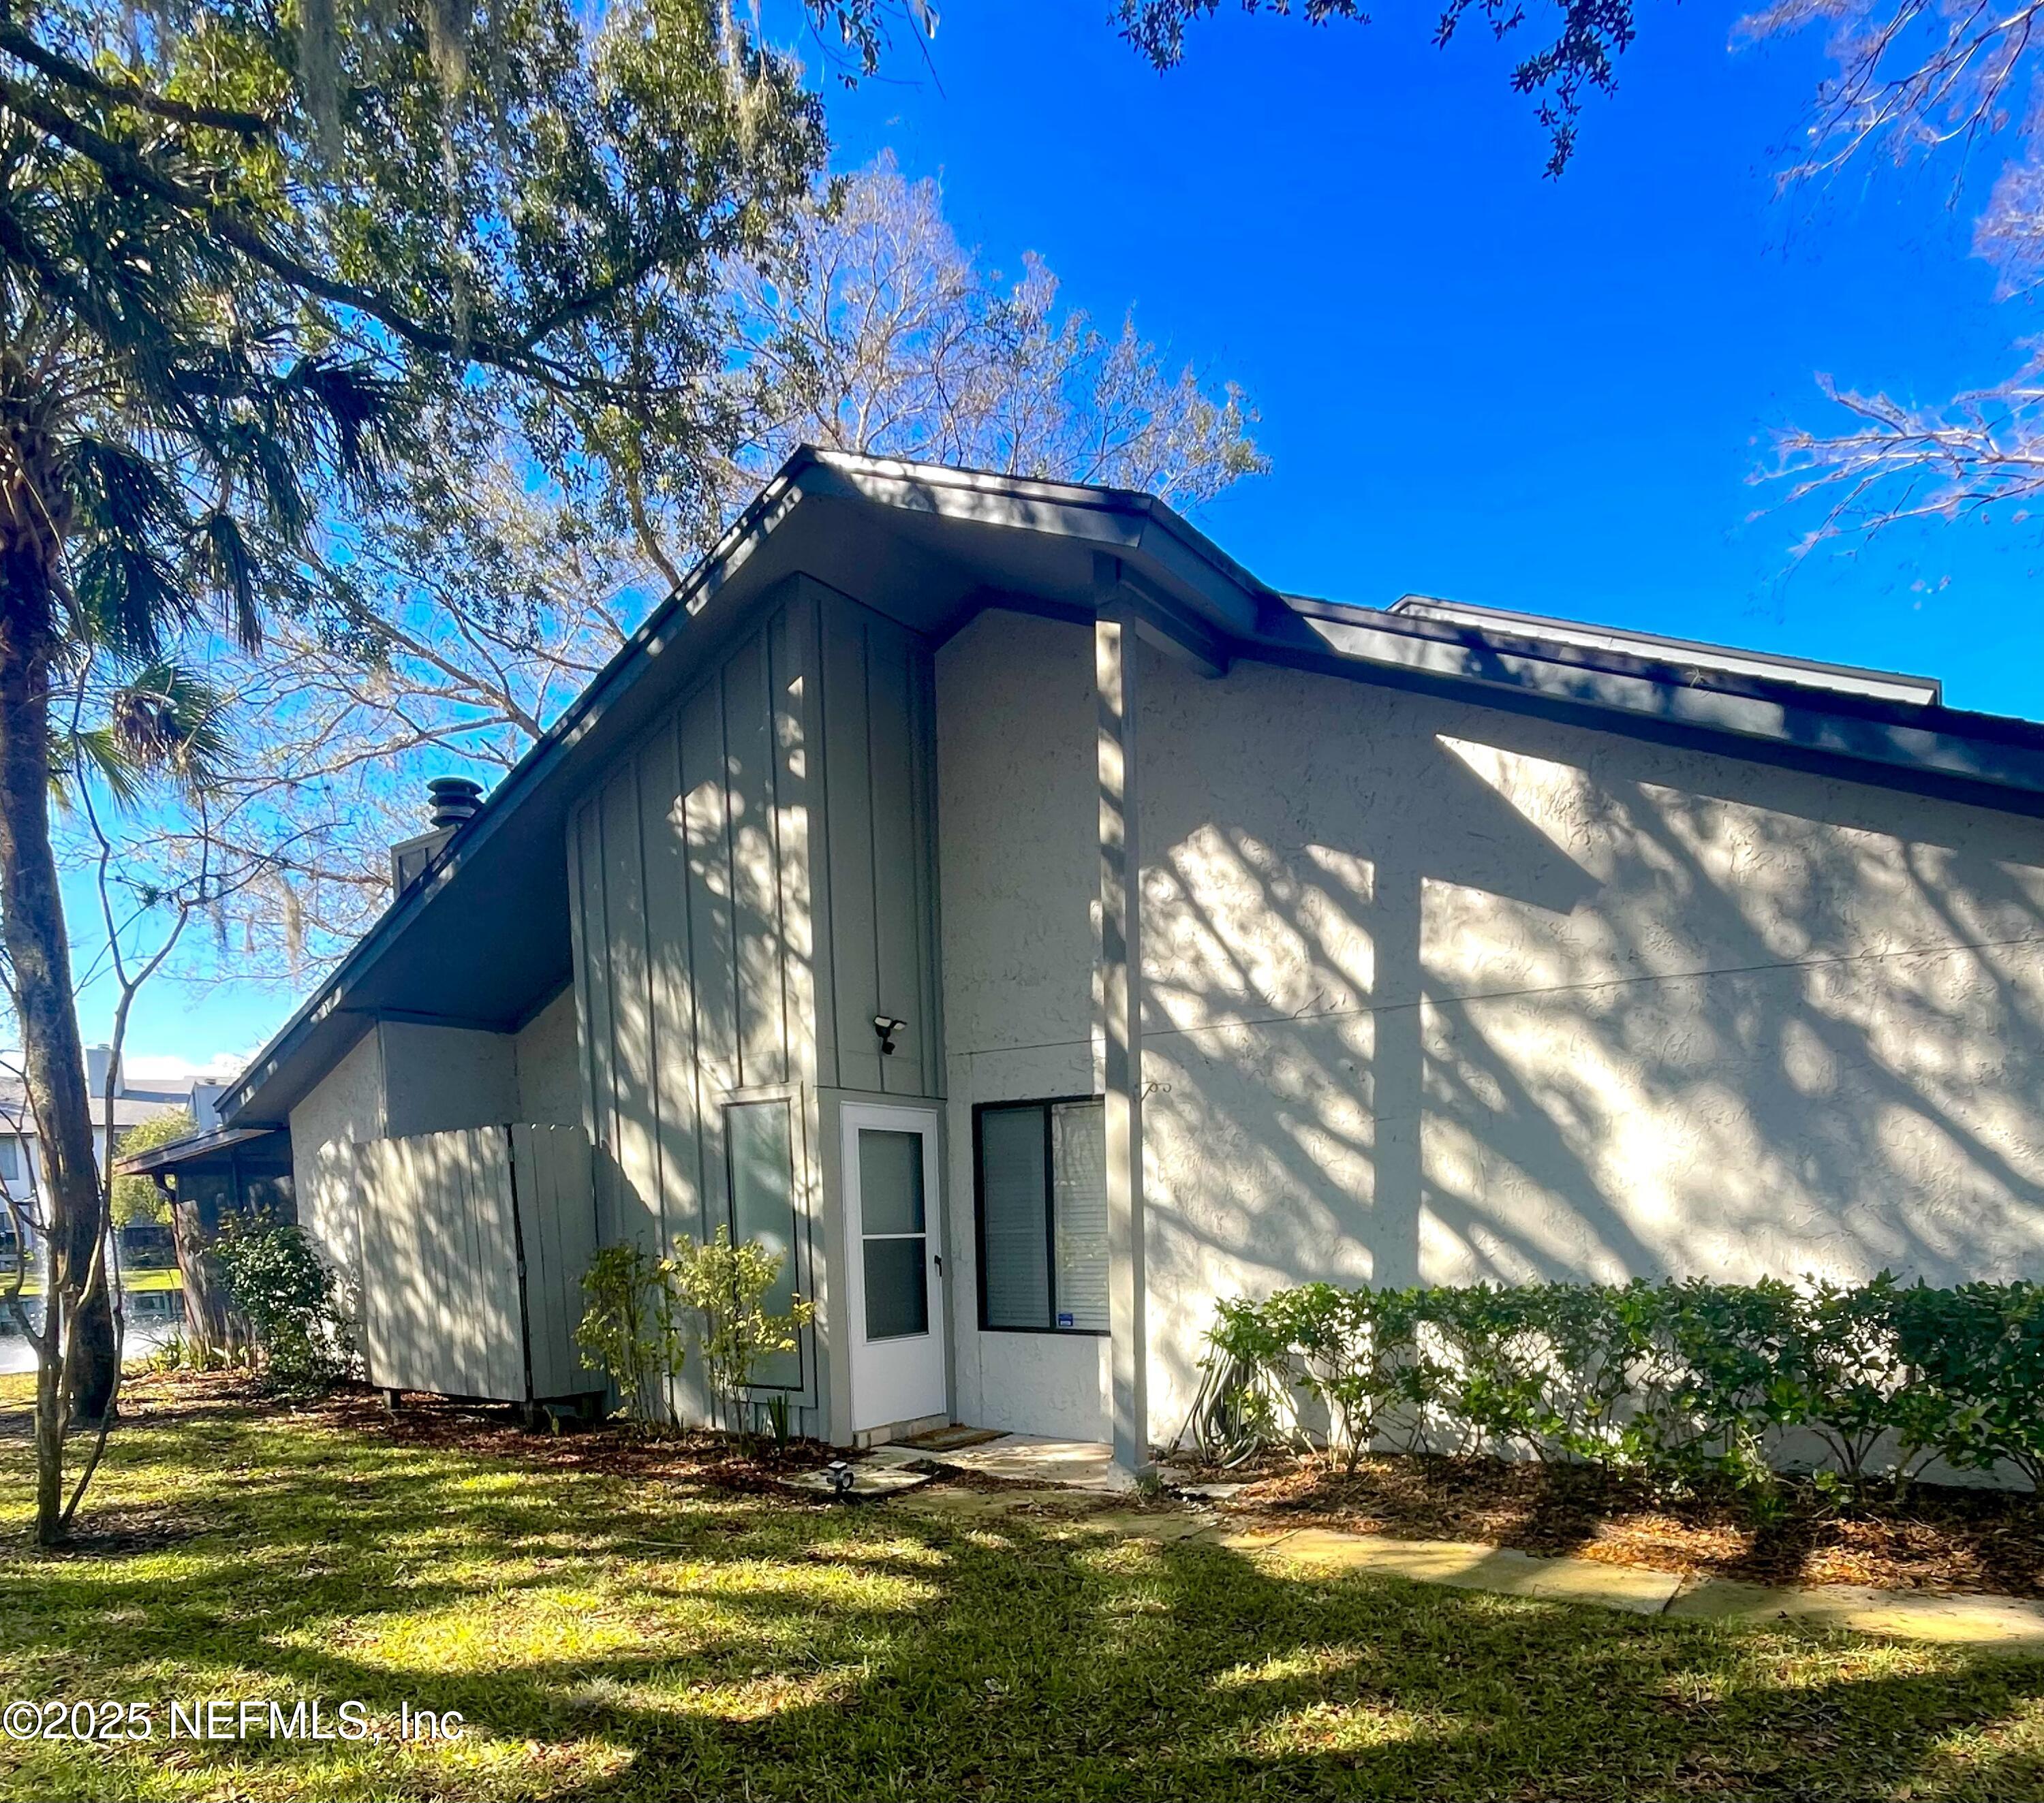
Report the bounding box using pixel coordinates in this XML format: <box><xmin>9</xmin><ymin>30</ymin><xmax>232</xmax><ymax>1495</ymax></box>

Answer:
<box><xmin>140</xmin><ymin>159</ymin><xmax>1265</xmax><ymax>982</ymax></box>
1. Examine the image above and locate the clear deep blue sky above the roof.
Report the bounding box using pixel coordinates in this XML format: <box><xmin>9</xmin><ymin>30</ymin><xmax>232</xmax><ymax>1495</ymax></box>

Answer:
<box><xmin>78</xmin><ymin>0</ymin><xmax>2044</xmax><ymax>1059</ymax></box>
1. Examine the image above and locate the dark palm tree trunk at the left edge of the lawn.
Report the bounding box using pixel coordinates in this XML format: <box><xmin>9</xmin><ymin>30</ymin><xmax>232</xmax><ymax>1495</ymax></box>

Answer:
<box><xmin>0</xmin><ymin>531</ymin><xmax>121</xmax><ymax>1539</ymax></box>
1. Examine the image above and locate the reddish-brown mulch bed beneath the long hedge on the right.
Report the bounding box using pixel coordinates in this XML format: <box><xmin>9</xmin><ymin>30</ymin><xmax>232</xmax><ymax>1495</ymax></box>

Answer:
<box><xmin>1200</xmin><ymin>1456</ymin><xmax>2044</xmax><ymax>1597</ymax></box>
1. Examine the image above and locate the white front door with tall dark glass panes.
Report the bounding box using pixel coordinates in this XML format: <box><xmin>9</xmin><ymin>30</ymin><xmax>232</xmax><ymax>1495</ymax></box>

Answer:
<box><xmin>844</xmin><ymin>1102</ymin><xmax>946</xmax><ymax>1433</ymax></box>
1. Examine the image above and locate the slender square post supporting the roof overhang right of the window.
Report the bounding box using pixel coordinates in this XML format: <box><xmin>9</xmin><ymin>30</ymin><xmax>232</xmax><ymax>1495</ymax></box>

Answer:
<box><xmin>1094</xmin><ymin>558</ymin><xmax>1151</xmax><ymax>1472</ymax></box>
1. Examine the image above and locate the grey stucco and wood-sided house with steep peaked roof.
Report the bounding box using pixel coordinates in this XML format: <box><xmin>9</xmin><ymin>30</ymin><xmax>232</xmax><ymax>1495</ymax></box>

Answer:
<box><xmin>199</xmin><ymin>450</ymin><xmax>2044</xmax><ymax>1464</ymax></box>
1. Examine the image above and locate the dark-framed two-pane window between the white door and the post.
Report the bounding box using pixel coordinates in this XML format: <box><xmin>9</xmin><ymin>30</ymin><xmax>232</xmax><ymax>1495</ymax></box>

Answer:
<box><xmin>979</xmin><ymin>1098</ymin><xmax>1108</xmax><ymax>1333</ymax></box>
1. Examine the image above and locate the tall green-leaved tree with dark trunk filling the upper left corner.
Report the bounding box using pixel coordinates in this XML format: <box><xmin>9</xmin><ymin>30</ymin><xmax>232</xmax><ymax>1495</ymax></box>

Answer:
<box><xmin>0</xmin><ymin>0</ymin><xmax>903</xmax><ymax>1541</ymax></box>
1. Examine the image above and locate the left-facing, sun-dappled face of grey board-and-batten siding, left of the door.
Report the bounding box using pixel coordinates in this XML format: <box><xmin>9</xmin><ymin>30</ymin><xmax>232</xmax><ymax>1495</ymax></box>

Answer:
<box><xmin>568</xmin><ymin>576</ymin><xmax>816</xmax><ymax>1409</ymax></box>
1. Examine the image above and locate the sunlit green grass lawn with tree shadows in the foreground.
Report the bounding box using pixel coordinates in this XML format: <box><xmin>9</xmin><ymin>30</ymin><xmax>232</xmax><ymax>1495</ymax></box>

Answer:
<box><xmin>0</xmin><ymin>1378</ymin><xmax>2044</xmax><ymax>1803</ymax></box>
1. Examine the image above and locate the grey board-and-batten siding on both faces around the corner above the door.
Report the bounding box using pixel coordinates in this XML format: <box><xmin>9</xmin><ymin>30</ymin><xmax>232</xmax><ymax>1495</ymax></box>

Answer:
<box><xmin>568</xmin><ymin>576</ymin><xmax>942</xmax><ymax>1431</ymax></box>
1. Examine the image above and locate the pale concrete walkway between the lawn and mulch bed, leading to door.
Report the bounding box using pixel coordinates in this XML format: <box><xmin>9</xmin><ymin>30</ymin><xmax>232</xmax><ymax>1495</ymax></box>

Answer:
<box><xmin>893</xmin><ymin>1471</ymin><xmax>2044</xmax><ymax>1654</ymax></box>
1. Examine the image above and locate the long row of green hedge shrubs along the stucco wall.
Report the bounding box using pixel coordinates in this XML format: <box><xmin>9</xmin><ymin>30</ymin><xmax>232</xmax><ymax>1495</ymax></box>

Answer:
<box><xmin>1192</xmin><ymin>1274</ymin><xmax>2044</xmax><ymax>1490</ymax></box>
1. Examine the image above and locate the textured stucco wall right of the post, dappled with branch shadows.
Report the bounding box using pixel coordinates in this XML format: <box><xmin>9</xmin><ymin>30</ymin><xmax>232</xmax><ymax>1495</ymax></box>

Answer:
<box><xmin>1143</xmin><ymin>662</ymin><xmax>2044</xmax><ymax>1427</ymax></box>
